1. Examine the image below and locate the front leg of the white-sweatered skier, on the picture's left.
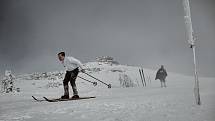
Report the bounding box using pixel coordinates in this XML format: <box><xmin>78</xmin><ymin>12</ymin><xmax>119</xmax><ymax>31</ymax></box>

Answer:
<box><xmin>62</xmin><ymin>71</ymin><xmax>71</xmax><ymax>98</ymax></box>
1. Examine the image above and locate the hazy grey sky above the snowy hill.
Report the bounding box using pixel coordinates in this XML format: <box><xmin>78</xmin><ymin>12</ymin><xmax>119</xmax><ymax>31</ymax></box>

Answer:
<box><xmin>0</xmin><ymin>0</ymin><xmax>215</xmax><ymax>76</ymax></box>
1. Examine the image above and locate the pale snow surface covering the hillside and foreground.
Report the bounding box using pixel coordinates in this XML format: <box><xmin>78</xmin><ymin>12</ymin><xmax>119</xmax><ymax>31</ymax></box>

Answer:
<box><xmin>0</xmin><ymin>62</ymin><xmax>215</xmax><ymax>121</ymax></box>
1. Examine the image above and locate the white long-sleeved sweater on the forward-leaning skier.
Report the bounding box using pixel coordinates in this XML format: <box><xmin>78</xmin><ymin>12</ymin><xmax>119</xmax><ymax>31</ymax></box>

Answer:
<box><xmin>62</xmin><ymin>56</ymin><xmax>83</xmax><ymax>71</ymax></box>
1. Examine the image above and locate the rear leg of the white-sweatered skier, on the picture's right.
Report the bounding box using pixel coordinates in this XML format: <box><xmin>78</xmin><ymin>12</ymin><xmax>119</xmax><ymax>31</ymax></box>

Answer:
<box><xmin>70</xmin><ymin>68</ymin><xmax>79</xmax><ymax>97</ymax></box>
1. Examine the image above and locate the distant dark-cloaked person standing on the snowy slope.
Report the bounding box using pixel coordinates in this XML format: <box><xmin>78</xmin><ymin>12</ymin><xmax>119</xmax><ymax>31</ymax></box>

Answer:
<box><xmin>155</xmin><ymin>65</ymin><xmax>167</xmax><ymax>87</ymax></box>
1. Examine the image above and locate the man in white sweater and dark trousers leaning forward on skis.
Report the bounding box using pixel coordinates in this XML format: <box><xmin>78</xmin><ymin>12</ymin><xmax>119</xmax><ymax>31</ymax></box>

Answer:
<box><xmin>58</xmin><ymin>52</ymin><xmax>85</xmax><ymax>99</ymax></box>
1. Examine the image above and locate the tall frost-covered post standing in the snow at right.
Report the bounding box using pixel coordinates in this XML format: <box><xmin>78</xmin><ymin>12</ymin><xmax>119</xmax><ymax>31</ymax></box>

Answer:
<box><xmin>183</xmin><ymin>0</ymin><xmax>201</xmax><ymax>105</ymax></box>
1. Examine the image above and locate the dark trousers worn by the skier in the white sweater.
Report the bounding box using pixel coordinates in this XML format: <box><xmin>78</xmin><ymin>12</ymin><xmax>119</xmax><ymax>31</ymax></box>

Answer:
<box><xmin>63</xmin><ymin>68</ymin><xmax>79</xmax><ymax>95</ymax></box>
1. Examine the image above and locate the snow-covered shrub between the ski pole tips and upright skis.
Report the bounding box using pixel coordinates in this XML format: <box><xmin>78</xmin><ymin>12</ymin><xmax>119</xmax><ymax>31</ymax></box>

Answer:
<box><xmin>119</xmin><ymin>74</ymin><xmax>135</xmax><ymax>88</ymax></box>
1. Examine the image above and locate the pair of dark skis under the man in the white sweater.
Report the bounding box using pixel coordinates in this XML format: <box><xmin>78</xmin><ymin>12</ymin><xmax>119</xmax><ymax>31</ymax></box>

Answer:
<box><xmin>32</xmin><ymin>96</ymin><xmax>96</xmax><ymax>102</ymax></box>
